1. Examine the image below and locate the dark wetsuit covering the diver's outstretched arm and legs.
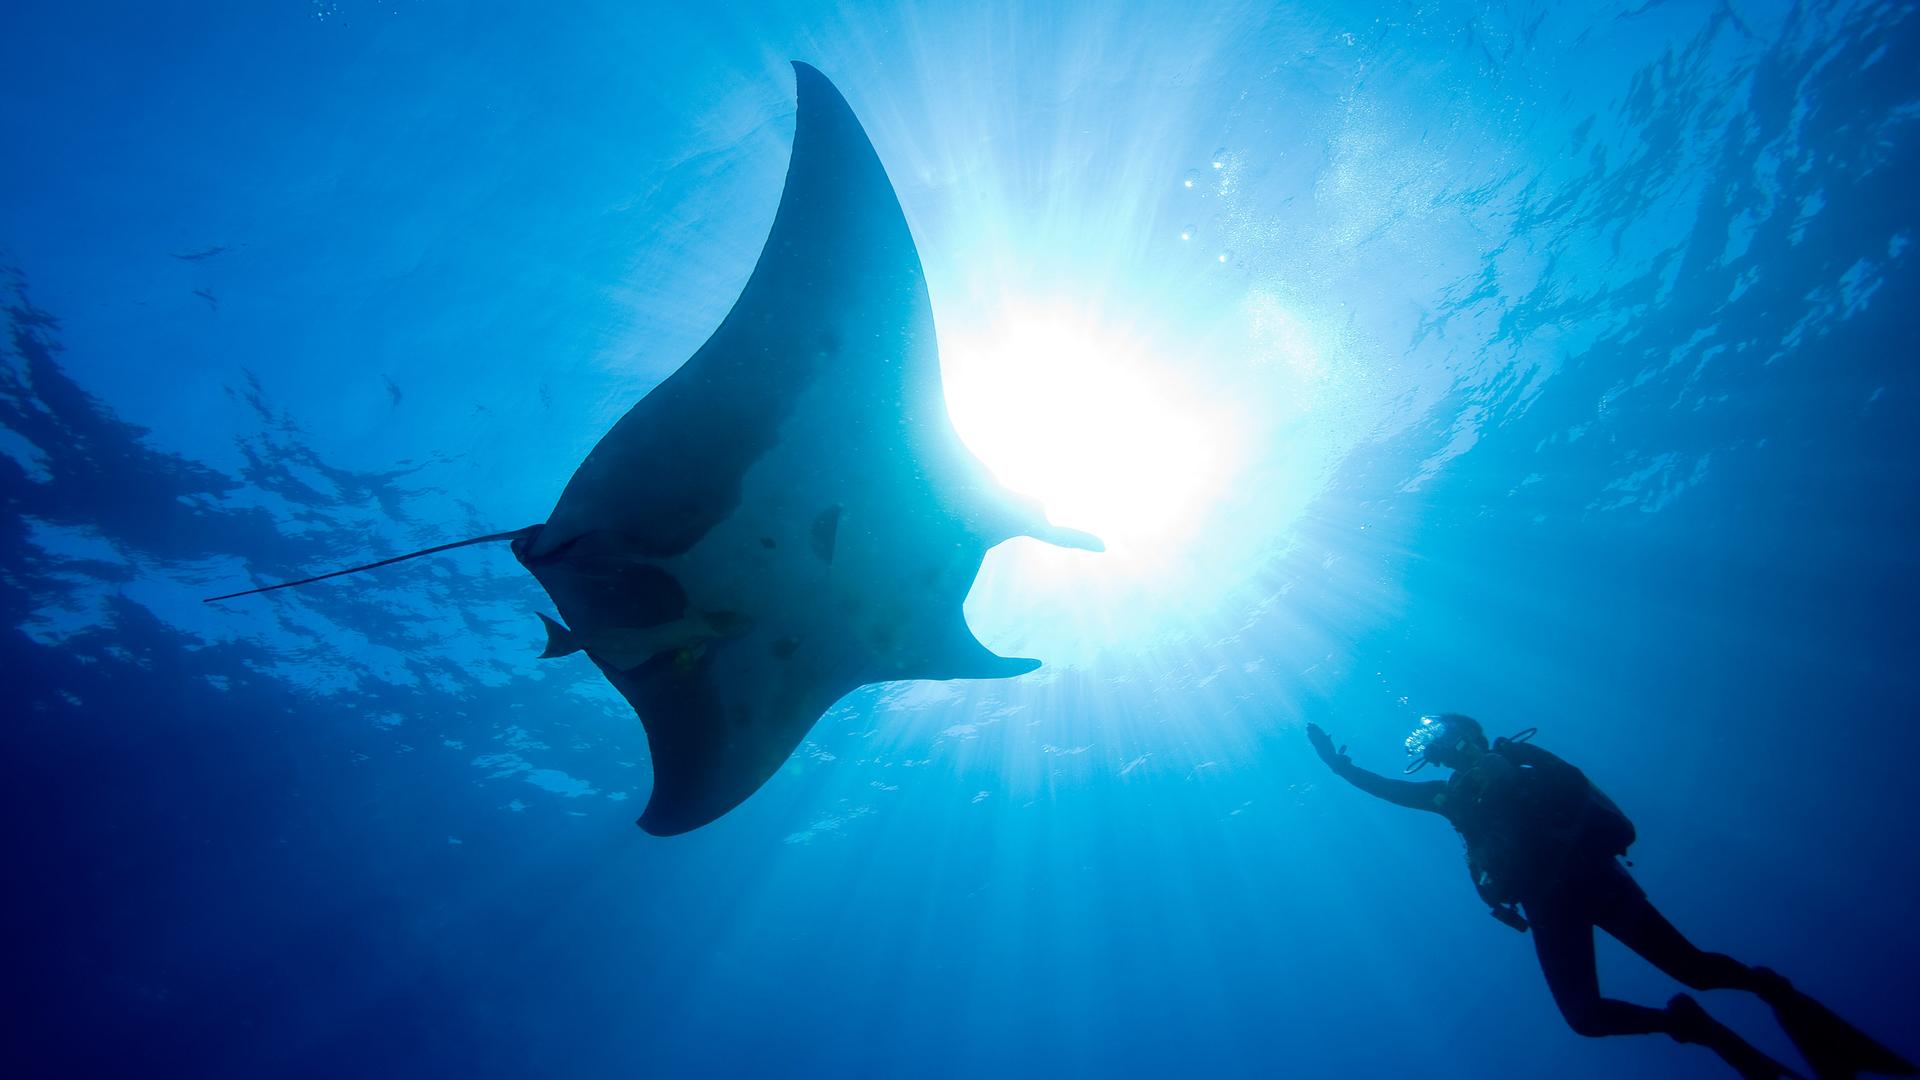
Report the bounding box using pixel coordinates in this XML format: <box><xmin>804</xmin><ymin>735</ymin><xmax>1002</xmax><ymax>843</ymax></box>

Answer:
<box><xmin>1334</xmin><ymin>763</ymin><xmax>1757</xmax><ymax>1036</ymax></box>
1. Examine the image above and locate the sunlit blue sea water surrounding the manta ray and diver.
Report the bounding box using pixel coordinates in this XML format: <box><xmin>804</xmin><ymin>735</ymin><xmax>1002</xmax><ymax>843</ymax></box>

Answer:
<box><xmin>0</xmin><ymin>0</ymin><xmax>1920</xmax><ymax>1080</ymax></box>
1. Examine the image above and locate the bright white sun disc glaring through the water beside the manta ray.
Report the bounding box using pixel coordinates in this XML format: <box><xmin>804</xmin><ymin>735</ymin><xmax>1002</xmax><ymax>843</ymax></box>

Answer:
<box><xmin>941</xmin><ymin>299</ymin><xmax>1236</xmax><ymax>561</ymax></box>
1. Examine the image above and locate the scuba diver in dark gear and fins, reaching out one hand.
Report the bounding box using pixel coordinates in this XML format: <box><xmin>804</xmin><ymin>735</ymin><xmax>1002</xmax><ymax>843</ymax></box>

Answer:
<box><xmin>1308</xmin><ymin>713</ymin><xmax>1920</xmax><ymax>1080</ymax></box>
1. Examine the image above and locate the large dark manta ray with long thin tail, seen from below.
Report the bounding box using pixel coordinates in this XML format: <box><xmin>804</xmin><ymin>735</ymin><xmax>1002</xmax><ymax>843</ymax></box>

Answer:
<box><xmin>211</xmin><ymin>61</ymin><xmax>1100</xmax><ymax>836</ymax></box>
